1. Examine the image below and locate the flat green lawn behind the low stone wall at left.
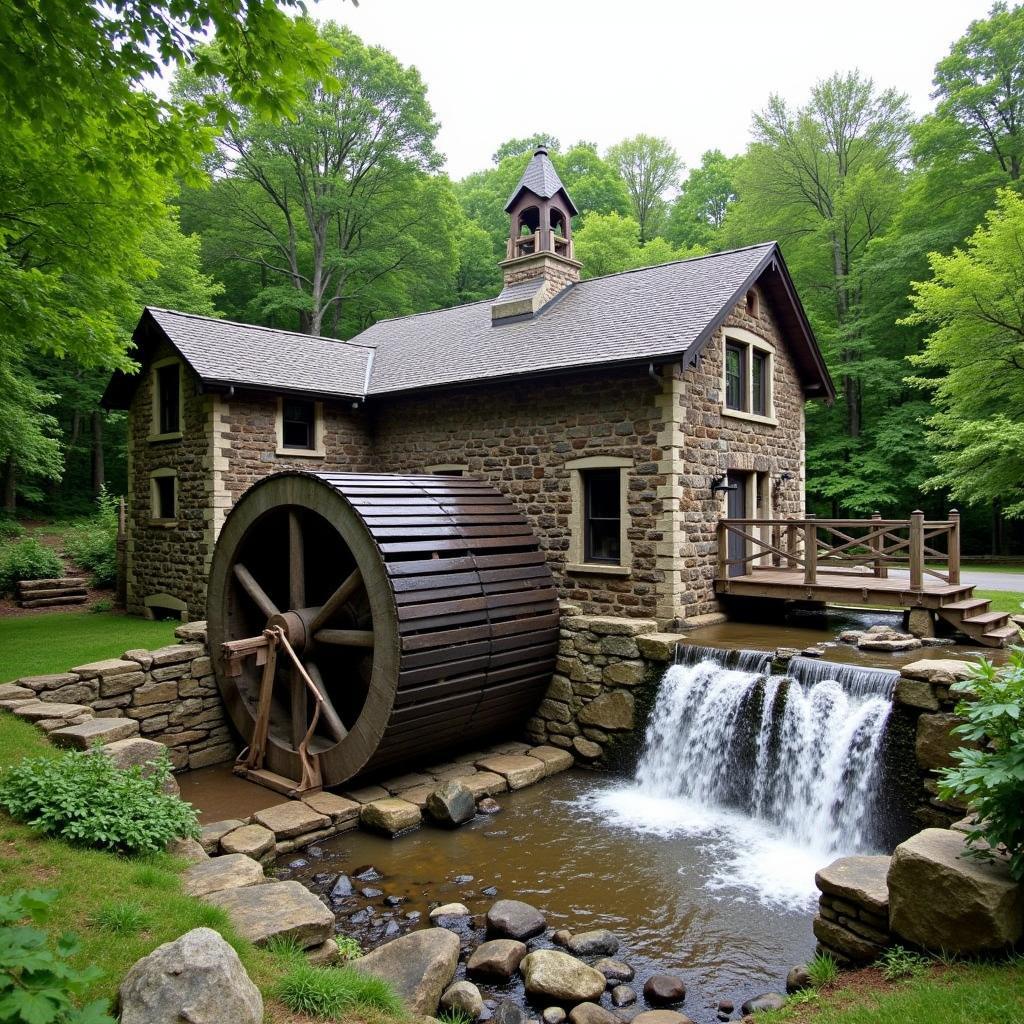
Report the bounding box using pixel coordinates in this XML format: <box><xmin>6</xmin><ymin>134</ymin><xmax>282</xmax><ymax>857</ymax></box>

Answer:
<box><xmin>0</xmin><ymin>611</ymin><xmax>179</xmax><ymax>683</ymax></box>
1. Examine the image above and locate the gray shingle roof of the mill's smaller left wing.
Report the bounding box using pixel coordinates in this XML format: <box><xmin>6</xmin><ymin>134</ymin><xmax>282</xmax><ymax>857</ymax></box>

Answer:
<box><xmin>142</xmin><ymin>306</ymin><xmax>371</xmax><ymax>397</ymax></box>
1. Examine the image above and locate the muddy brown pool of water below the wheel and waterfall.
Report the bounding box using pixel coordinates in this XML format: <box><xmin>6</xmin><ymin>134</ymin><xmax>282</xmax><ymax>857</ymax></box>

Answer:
<box><xmin>279</xmin><ymin>771</ymin><xmax>814</xmax><ymax>1022</ymax></box>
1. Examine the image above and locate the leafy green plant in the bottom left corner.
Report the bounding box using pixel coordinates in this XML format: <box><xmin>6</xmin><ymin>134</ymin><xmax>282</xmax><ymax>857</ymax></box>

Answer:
<box><xmin>0</xmin><ymin>889</ymin><xmax>114</xmax><ymax>1024</ymax></box>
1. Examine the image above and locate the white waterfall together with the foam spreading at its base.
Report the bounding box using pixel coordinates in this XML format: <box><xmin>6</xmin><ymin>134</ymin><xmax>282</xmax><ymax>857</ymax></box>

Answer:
<box><xmin>583</xmin><ymin>652</ymin><xmax>898</xmax><ymax>906</ymax></box>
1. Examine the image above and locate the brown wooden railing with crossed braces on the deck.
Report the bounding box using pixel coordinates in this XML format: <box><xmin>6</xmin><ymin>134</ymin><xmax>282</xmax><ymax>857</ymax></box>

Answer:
<box><xmin>718</xmin><ymin>509</ymin><xmax>961</xmax><ymax>591</ymax></box>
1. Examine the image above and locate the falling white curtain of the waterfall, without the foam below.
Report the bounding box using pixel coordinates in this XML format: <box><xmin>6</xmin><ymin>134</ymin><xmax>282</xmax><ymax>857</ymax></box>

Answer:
<box><xmin>636</xmin><ymin>647</ymin><xmax>899</xmax><ymax>854</ymax></box>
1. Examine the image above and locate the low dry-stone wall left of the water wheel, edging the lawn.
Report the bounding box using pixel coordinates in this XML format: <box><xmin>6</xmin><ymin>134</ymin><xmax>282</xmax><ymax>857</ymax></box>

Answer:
<box><xmin>0</xmin><ymin>623</ymin><xmax>230</xmax><ymax>770</ymax></box>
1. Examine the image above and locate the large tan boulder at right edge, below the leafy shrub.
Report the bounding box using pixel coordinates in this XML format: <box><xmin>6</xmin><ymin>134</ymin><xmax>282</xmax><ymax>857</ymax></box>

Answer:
<box><xmin>889</xmin><ymin>828</ymin><xmax>1024</xmax><ymax>953</ymax></box>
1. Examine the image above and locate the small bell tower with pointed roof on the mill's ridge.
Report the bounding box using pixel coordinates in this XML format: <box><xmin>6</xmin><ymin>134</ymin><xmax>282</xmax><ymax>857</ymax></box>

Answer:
<box><xmin>490</xmin><ymin>145</ymin><xmax>583</xmax><ymax>323</ymax></box>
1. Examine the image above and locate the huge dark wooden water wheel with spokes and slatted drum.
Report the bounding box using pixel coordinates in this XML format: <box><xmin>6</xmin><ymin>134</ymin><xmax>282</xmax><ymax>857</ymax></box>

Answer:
<box><xmin>207</xmin><ymin>472</ymin><xmax>558</xmax><ymax>794</ymax></box>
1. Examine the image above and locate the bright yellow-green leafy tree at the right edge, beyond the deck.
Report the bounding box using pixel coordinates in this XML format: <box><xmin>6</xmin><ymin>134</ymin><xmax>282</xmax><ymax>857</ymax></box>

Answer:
<box><xmin>907</xmin><ymin>188</ymin><xmax>1024</xmax><ymax>518</ymax></box>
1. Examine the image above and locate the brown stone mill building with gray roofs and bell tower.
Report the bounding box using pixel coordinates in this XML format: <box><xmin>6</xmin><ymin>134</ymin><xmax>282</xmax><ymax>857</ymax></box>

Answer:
<box><xmin>104</xmin><ymin>146</ymin><xmax>835</xmax><ymax>626</ymax></box>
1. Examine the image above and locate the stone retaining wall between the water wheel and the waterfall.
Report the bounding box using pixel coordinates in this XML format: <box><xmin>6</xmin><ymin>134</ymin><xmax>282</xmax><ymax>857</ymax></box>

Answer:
<box><xmin>526</xmin><ymin>604</ymin><xmax>685</xmax><ymax>767</ymax></box>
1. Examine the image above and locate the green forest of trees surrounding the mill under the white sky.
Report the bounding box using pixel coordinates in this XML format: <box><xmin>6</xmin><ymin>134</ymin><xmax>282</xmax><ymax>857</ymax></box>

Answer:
<box><xmin>0</xmin><ymin>0</ymin><xmax>1024</xmax><ymax>552</ymax></box>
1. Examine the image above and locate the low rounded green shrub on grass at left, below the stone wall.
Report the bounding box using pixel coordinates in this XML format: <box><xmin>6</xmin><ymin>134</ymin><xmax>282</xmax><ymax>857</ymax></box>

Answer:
<box><xmin>0</xmin><ymin>751</ymin><xmax>199</xmax><ymax>854</ymax></box>
